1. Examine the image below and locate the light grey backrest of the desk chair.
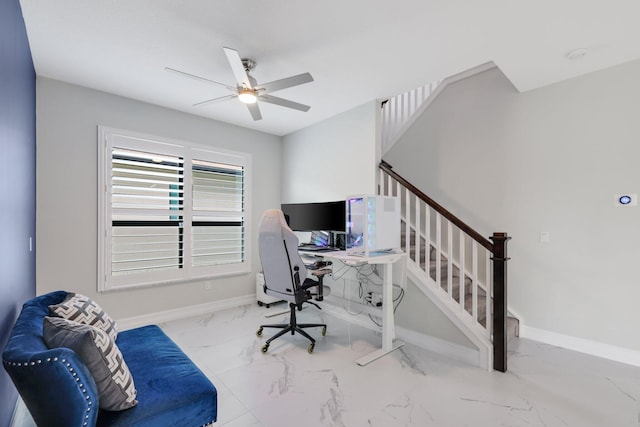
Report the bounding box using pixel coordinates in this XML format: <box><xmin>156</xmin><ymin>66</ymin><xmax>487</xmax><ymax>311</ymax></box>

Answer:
<box><xmin>258</xmin><ymin>209</ymin><xmax>307</xmax><ymax>303</ymax></box>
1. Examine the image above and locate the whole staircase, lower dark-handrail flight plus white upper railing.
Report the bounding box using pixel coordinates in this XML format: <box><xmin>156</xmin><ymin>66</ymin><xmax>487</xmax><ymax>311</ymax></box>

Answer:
<box><xmin>378</xmin><ymin>62</ymin><xmax>518</xmax><ymax>372</ymax></box>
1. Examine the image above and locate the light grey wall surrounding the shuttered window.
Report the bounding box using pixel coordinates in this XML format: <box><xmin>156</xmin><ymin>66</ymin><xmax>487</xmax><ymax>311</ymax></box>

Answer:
<box><xmin>36</xmin><ymin>78</ymin><xmax>282</xmax><ymax>319</ymax></box>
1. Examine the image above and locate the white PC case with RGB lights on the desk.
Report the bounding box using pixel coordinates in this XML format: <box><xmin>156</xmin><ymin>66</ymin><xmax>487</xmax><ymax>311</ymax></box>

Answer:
<box><xmin>345</xmin><ymin>196</ymin><xmax>400</xmax><ymax>256</ymax></box>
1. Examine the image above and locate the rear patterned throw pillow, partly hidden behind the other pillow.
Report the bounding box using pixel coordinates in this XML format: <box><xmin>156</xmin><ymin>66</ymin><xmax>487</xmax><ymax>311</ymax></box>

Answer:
<box><xmin>49</xmin><ymin>292</ymin><xmax>118</xmax><ymax>340</ymax></box>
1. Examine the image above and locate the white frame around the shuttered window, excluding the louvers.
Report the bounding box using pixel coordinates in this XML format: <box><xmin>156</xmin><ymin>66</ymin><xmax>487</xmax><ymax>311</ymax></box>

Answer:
<box><xmin>97</xmin><ymin>126</ymin><xmax>252</xmax><ymax>292</ymax></box>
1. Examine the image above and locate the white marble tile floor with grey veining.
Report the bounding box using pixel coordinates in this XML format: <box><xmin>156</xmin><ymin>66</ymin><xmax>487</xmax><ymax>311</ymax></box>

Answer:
<box><xmin>12</xmin><ymin>305</ymin><xmax>640</xmax><ymax>427</ymax></box>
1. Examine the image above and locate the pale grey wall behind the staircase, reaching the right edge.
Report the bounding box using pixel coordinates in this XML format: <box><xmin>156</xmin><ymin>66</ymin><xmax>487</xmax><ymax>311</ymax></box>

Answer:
<box><xmin>384</xmin><ymin>61</ymin><xmax>640</xmax><ymax>350</ymax></box>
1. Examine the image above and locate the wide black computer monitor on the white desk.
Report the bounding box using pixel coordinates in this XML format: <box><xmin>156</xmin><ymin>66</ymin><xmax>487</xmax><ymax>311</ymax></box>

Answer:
<box><xmin>281</xmin><ymin>200</ymin><xmax>346</xmax><ymax>232</ymax></box>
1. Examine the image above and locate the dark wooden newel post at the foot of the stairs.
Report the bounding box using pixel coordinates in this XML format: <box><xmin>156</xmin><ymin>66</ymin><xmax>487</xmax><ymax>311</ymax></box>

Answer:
<box><xmin>489</xmin><ymin>233</ymin><xmax>511</xmax><ymax>372</ymax></box>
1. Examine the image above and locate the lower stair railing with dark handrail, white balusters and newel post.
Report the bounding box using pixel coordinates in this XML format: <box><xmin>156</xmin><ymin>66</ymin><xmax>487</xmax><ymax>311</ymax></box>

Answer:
<box><xmin>379</xmin><ymin>161</ymin><xmax>510</xmax><ymax>372</ymax></box>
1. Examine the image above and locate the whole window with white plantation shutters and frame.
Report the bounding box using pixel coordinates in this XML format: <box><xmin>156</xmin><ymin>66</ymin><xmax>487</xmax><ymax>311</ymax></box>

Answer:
<box><xmin>98</xmin><ymin>127</ymin><xmax>251</xmax><ymax>291</ymax></box>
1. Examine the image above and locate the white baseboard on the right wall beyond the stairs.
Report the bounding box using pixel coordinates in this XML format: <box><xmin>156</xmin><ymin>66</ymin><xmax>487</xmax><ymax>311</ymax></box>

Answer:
<box><xmin>520</xmin><ymin>323</ymin><xmax>640</xmax><ymax>366</ymax></box>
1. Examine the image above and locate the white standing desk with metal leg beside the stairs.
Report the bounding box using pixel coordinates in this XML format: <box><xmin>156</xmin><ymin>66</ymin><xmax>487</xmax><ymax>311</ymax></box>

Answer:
<box><xmin>300</xmin><ymin>251</ymin><xmax>406</xmax><ymax>366</ymax></box>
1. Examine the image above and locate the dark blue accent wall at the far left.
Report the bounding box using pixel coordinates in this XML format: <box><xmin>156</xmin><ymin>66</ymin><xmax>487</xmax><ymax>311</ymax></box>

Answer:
<box><xmin>0</xmin><ymin>0</ymin><xmax>36</xmax><ymax>427</ymax></box>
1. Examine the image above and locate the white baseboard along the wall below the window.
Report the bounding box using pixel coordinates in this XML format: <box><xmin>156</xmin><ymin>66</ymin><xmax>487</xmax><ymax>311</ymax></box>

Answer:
<box><xmin>117</xmin><ymin>294</ymin><xmax>256</xmax><ymax>331</ymax></box>
